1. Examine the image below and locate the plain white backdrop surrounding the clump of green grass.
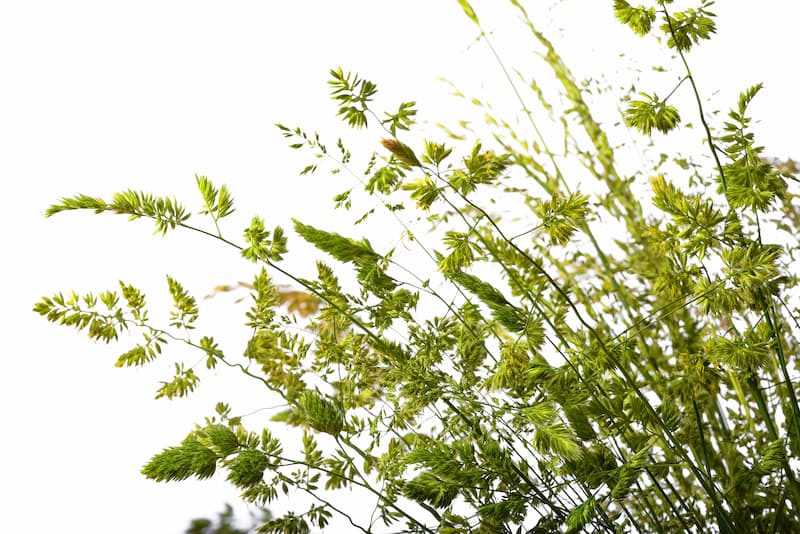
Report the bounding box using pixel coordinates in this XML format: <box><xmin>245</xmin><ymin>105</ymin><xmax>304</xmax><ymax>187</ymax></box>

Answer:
<box><xmin>0</xmin><ymin>0</ymin><xmax>800</xmax><ymax>533</ymax></box>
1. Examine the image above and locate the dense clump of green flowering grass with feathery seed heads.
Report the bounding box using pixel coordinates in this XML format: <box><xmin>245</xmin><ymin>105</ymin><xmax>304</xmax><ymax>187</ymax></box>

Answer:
<box><xmin>35</xmin><ymin>0</ymin><xmax>800</xmax><ymax>533</ymax></box>
